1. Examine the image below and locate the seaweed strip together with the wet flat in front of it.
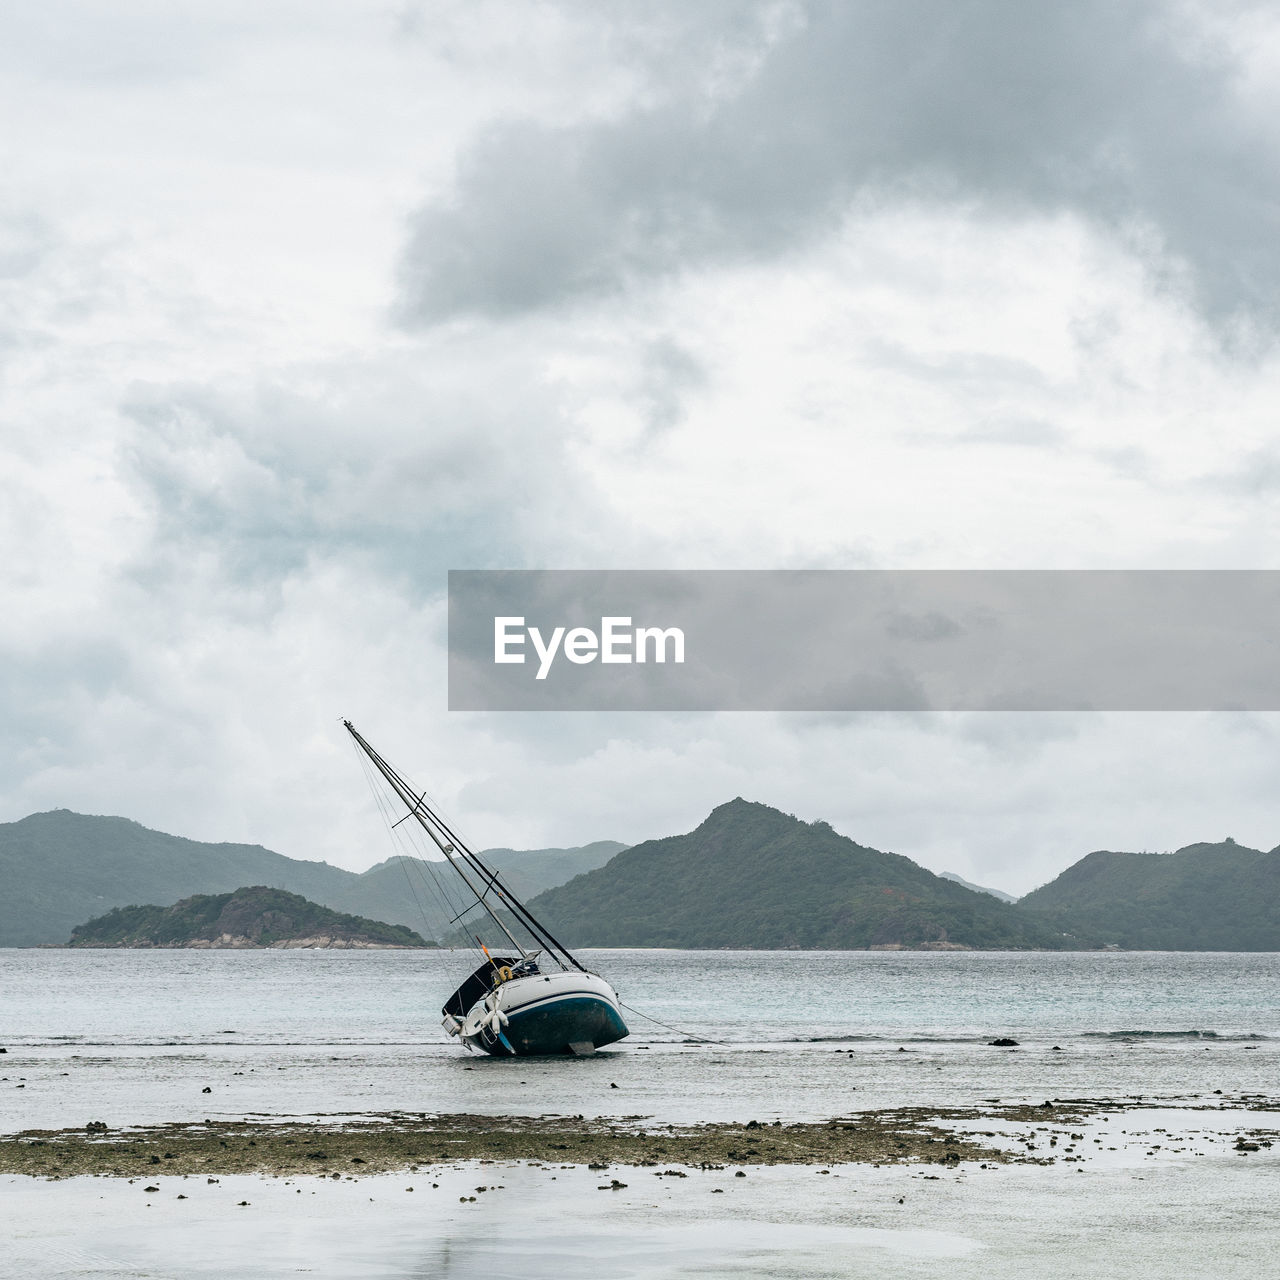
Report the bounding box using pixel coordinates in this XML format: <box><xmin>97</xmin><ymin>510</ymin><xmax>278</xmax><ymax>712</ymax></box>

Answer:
<box><xmin>0</xmin><ymin>1097</ymin><xmax>1280</xmax><ymax>1280</ymax></box>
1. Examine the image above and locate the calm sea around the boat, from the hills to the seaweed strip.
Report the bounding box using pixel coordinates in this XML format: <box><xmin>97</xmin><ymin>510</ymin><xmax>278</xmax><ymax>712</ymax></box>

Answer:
<box><xmin>0</xmin><ymin>950</ymin><xmax>1280</xmax><ymax>1132</ymax></box>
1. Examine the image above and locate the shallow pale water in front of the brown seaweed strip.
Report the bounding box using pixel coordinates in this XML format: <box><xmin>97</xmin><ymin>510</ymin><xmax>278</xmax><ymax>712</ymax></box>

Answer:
<box><xmin>0</xmin><ymin>1157</ymin><xmax>1280</xmax><ymax>1280</ymax></box>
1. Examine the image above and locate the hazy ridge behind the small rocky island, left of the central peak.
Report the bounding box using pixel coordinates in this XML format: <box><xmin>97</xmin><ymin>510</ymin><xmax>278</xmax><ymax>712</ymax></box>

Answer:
<box><xmin>0</xmin><ymin>809</ymin><xmax>623</xmax><ymax>947</ymax></box>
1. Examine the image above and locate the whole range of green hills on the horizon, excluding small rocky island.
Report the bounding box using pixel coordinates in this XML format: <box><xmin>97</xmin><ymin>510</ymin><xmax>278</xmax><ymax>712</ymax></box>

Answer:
<box><xmin>12</xmin><ymin>800</ymin><xmax>1280</xmax><ymax>951</ymax></box>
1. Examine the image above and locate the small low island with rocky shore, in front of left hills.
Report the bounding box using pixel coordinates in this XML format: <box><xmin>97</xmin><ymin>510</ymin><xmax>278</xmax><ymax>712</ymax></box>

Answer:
<box><xmin>67</xmin><ymin>884</ymin><xmax>435</xmax><ymax>950</ymax></box>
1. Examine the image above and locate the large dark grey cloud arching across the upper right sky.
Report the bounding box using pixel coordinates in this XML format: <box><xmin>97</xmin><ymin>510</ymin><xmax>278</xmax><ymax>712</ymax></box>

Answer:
<box><xmin>401</xmin><ymin>0</ymin><xmax>1280</xmax><ymax>325</ymax></box>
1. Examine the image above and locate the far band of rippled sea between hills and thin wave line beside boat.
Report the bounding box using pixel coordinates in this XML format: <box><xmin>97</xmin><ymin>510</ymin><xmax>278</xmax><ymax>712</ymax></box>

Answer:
<box><xmin>10</xmin><ymin>950</ymin><xmax>1280</xmax><ymax>1044</ymax></box>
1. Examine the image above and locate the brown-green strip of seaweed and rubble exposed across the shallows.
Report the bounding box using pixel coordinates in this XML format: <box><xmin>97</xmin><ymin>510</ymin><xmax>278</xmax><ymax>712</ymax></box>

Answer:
<box><xmin>0</xmin><ymin>1096</ymin><xmax>1280</xmax><ymax>1179</ymax></box>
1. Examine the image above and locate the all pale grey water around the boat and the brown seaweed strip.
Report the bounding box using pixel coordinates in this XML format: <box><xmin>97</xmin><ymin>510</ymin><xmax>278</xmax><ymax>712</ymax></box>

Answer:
<box><xmin>0</xmin><ymin>950</ymin><xmax>1280</xmax><ymax>1280</ymax></box>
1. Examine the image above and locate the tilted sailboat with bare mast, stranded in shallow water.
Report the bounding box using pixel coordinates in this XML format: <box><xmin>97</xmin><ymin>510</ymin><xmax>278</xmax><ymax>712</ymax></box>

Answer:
<box><xmin>343</xmin><ymin>721</ymin><xmax>628</xmax><ymax>1057</ymax></box>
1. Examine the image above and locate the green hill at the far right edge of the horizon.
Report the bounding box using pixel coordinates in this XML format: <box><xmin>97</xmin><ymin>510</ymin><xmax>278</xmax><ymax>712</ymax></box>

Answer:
<box><xmin>1018</xmin><ymin>840</ymin><xmax>1280</xmax><ymax>951</ymax></box>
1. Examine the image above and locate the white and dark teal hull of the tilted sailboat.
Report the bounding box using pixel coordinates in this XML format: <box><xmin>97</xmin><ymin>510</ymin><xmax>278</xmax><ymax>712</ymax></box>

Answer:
<box><xmin>462</xmin><ymin>974</ymin><xmax>630</xmax><ymax>1057</ymax></box>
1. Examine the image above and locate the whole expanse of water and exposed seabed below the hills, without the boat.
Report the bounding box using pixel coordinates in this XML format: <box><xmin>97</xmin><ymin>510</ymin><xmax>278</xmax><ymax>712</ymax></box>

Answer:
<box><xmin>0</xmin><ymin>951</ymin><xmax>1280</xmax><ymax>1280</ymax></box>
